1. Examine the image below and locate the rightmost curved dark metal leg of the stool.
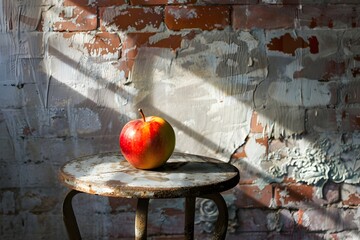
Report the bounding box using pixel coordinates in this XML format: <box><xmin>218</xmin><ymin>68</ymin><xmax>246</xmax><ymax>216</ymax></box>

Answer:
<box><xmin>201</xmin><ymin>193</ymin><xmax>229</xmax><ymax>240</ymax></box>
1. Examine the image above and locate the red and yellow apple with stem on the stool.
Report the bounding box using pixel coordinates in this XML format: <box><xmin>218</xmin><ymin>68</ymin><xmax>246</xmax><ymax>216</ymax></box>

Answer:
<box><xmin>119</xmin><ymin>109</ymin><xmax>175</xmax><ymax>169</ymax></box>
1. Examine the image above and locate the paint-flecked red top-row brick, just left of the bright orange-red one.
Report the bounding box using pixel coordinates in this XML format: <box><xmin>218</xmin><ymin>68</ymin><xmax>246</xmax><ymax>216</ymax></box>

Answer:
<box><xmin>100</xmin><ymin>7</ymin><xmax>163</xmax><ymax>32</ymax></box>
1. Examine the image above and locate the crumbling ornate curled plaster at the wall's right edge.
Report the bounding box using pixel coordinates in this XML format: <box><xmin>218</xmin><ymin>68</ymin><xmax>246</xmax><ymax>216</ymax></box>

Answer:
<box><xmin>263</xmin><ymin>134</ymin><xmax>360</xmax><ymax>196</ymax></box>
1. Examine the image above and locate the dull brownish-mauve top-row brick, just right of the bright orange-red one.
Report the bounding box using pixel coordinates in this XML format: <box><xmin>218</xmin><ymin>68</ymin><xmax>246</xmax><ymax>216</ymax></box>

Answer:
<box><xmin>232</xmin><ymin>5</ymin><xmax>296</xmax><ymax>29</ymax></box>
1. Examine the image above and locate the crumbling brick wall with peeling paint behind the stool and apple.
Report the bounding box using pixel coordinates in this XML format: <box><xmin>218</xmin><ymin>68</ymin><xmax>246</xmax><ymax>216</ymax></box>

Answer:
<box><xmin>0</xmin><ymin>0</ymin><xmax>360</xmax><ymax>239</ymax></box>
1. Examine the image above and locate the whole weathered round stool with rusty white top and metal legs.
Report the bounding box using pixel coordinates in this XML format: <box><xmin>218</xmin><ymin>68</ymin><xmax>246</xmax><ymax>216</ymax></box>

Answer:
<box><xmin>60</xmin><ymin>153</ymin><xmax>240</xmax><ymax>240</ymax></box>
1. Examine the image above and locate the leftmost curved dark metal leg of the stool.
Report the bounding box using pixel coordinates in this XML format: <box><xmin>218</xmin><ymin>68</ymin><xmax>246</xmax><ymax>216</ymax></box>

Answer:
<box><xmin>63</xmin><ymin>190</ymin><xmax>81</xmax><ymax>240</ymax></box>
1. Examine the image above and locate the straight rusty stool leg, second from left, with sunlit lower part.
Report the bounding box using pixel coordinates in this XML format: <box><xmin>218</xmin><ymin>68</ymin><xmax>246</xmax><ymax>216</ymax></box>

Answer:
<box><xmin>135</xmin><ymin>198</ymin><xmax>149</xmax><ymax>240</ymax></box>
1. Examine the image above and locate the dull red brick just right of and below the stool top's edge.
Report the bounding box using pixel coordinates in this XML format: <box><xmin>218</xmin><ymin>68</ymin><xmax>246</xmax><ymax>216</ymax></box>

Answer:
<box><xmin>234</xmin><ymin>185</ymin><xmax>272</xmax><ymax>208</ymax></box>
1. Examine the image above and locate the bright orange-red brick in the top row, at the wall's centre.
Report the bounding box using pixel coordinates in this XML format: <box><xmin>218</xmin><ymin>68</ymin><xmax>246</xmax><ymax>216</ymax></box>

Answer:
<box><xmin>165</xmin><ymin>6</ymin><xmax>230</xmax><ymax>30</ymax></box>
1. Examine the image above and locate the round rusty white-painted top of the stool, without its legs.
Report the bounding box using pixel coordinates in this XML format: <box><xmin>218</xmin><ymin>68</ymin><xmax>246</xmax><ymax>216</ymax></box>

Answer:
<box><xmin>60</xmin><ymin>153</ymin><xmax>240</xmax><ymax>198</ymax></box>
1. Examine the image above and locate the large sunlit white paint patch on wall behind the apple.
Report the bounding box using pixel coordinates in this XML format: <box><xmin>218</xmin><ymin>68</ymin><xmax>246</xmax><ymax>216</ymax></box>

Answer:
<box><xmin>132</xmin><ymin>44</ymin><xmax>251</xmax><ymax>160</ymax></box>
